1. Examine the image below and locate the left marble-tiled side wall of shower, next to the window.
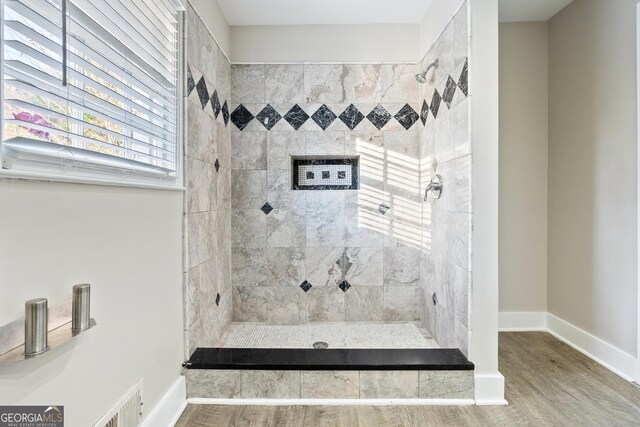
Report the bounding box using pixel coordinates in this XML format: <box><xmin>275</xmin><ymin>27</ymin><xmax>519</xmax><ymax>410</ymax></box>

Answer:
<box><xmin>185</xmin><ymin>6</ymin><xmax>232</xmax><ymax>353</ymax></box>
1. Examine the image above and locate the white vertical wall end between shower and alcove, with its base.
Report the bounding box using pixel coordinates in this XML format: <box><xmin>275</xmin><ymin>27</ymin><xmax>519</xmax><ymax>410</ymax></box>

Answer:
<box><xmin>469</xmin><ymin>0</ymin><xmax>506</xmax><ymax>404</ymax></box>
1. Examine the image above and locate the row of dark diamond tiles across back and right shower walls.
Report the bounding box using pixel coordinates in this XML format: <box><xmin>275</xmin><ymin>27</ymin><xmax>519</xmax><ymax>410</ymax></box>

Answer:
<box><xmin>228</xmin><ymin>60</ymin><xmax>468</xmax><ymax>130</ymax></box>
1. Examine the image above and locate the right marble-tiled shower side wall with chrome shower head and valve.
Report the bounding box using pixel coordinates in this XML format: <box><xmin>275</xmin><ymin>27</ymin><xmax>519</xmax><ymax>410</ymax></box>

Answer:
<box><xmin>419</xmin><ymin>2</ymin><xmax>473</xmax><ymax>354</ymax></box>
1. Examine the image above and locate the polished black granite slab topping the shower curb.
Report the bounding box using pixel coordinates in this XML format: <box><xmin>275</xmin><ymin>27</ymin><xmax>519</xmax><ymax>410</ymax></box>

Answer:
<box><xmin>182</xmin><ymin>348</ymin><xmax>474</xmax><ymax>371</ymax></box>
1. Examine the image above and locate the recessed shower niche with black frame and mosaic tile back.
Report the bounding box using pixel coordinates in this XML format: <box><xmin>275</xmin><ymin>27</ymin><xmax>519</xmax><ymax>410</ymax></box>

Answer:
<box><xmin>291</xmin><ymin>157</ymin><xmax>359</xmax><ymax>190</ymax></box>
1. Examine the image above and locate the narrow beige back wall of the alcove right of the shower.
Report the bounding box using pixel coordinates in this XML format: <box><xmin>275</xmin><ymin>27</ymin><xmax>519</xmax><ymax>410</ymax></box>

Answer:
<box><xmin>500</xmin><ymin>22</ymin><xmax>548</xmax><ymax>312</ymax></box>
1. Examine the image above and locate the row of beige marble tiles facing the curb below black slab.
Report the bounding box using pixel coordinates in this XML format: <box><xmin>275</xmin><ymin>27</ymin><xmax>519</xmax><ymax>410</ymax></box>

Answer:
<box><xmin>183</xmin><ymin>369</ymin><xmax>474</xmax><ymax>399</ymax></box>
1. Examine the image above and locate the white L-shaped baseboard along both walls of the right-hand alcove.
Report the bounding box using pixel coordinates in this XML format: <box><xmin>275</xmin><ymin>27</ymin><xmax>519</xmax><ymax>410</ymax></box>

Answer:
<box><xmin>499</xmin><ymin>312</ymin><xmax>640</xmax><ymax>381</ymax></box>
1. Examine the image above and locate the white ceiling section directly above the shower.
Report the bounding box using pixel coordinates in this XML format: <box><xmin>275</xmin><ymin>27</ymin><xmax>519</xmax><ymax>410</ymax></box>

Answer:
<box><xmin>217</xmin><ymin>0</ymin><xmax>432</xmax><ymax>25</ymax></box>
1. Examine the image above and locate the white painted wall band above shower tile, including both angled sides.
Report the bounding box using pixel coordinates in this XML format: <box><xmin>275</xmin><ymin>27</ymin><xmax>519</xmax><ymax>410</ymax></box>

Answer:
<box><xmin>196</xmin><ymin>0</ymin><xmax>464</xmax><ymax>63</ymax></box>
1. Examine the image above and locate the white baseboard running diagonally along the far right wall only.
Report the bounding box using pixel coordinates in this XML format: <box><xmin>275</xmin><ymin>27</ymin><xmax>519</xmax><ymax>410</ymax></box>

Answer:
<box><xmin>547</xmin><ymin>313</ymin><xmax>636</xmax><ymax>381</ymax></box>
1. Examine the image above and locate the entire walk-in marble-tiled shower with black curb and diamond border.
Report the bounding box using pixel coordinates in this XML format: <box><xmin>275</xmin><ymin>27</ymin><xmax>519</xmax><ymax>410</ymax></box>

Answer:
<box><xmin>185</xmin><ymin>0</ymin><xmax>473</xmax><ymax>398</ymax></box>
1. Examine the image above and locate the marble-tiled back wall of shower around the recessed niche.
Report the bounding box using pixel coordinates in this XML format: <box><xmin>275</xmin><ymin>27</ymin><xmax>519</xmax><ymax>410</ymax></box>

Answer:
<box><xmin>230</xmin><ymin>64</ymin><xmax>440</xmax><ymax>324</ymax></box>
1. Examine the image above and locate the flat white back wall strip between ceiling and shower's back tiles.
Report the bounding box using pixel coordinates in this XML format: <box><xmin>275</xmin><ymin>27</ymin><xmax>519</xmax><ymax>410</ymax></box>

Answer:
<box><xmin>231</xmin><ymin>24</ymin><xmax>420</xmax><ymax>63</ymax></box>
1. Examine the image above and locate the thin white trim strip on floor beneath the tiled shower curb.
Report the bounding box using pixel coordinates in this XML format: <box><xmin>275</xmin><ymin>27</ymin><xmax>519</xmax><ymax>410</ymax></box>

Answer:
<box><xmin>188</xmin><ymin>397</ymin><xmax>475</xmax><ymax>406</ymax></box>
